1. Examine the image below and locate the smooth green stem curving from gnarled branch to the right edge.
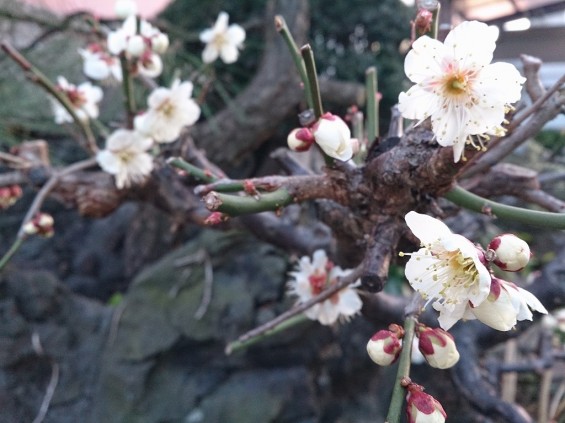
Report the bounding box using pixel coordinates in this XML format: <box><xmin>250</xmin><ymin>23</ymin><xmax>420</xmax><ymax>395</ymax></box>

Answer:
<box><xmin>444</xmin><ymin>186</ymin><xmax>565</xmax><ymax>229</ymax></box>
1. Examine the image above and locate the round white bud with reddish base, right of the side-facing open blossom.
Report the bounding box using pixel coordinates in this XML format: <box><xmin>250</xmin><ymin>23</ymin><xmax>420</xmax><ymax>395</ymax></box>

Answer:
<box><xmin>488</xmin><ymin>234</ymin><xmax>532</xmax><ymax>272</ymax></box>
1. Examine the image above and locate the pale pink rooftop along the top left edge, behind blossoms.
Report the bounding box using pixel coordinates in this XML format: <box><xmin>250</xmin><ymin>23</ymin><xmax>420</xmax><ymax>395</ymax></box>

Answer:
<box><xmin>20</xmin><ymin>0</ymin><xmax>171</xmax><ymax>19</ymax></box>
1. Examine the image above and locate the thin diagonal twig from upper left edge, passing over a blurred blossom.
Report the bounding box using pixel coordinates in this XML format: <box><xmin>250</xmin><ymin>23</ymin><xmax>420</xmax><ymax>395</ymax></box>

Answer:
<box><xmin>2</xmin><ymin>42</ymin><xmax>98</xmax><ymax>153</ymax></box>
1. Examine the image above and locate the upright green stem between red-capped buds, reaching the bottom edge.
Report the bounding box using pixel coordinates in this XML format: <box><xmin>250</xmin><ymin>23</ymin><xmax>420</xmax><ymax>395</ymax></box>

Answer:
<box><xmin>385</xmin><ymin>315</ymin><xmax>416</xmax><ymax>423</ymax></box>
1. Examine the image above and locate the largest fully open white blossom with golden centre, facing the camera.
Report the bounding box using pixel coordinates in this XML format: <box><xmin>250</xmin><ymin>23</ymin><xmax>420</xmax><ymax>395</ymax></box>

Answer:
<box><xmin>398</xmin><ymin>21</ymin><xmax>525</xmax><ymax>162</ymax></box>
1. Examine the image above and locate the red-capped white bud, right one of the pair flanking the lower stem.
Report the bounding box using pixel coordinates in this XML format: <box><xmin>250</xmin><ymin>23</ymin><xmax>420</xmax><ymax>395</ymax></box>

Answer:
<box><xmin>416</xmin><ymin>325</ymin><xmax>459</xmax><ymax>369</ymax></box>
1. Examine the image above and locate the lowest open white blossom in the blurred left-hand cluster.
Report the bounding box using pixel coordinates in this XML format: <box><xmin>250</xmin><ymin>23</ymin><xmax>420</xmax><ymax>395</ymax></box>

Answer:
<box><xmin>96</xmin><ymin>129</ymin><xmax>153</xmax><ymax>189</ymax></box>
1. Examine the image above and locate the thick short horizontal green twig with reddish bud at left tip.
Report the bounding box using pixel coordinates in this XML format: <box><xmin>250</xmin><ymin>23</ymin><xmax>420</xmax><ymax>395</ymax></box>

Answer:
<box><xmin>204</xmin><ymin>188</ymin><xmax>294</xmax><ymax>217</ymax></box>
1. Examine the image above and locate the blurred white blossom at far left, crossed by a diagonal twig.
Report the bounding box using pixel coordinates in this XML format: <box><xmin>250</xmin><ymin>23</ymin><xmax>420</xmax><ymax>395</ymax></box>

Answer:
<box><xmin>51</xmin><ymin>76</ymin><xmax>103</xmax><ymax>124</ymax></box>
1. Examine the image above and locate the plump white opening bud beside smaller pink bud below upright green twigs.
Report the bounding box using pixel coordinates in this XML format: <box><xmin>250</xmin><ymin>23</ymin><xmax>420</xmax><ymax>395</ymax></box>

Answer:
<box><xmin>311</xmin><ymin>113</ymin><xmax>357</xmax><ymax>162</ymax></box>
